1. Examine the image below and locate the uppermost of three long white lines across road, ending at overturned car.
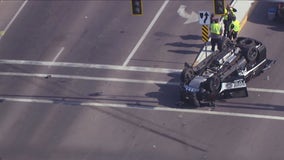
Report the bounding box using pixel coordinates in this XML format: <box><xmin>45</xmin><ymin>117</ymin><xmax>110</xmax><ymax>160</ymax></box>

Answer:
<box><xmin>0</xmin><ymin>59</ymin><xmax>181</xmax><ymax>73</ymax></box>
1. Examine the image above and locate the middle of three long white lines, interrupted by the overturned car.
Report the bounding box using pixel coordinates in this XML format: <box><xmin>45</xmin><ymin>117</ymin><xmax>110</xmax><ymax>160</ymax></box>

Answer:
<box><xmin>0</xmin><ymin>72</ymin><xmax>284</xmax><ymax>94</ymax></box>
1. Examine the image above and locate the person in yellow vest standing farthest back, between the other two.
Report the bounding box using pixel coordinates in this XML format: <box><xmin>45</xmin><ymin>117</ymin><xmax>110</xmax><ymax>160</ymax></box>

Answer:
<box><xmin>223</xmin><ymin>4</ymin><xmax>237</xmax><ymax>37</ymax></box>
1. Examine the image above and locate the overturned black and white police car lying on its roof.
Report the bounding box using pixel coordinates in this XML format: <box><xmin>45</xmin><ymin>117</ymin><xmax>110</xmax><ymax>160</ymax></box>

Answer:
<box><xmin>180</xmin><ymin>37</ymin><xmax>272</xmax><ymax>107</ymax></box>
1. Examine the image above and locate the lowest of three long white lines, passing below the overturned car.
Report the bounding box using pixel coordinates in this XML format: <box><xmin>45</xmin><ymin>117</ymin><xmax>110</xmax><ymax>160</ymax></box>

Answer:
<box><xmin>0</xmin><ymin>96</ymin><xmax>284</xmax><ymax>121</ymax></box>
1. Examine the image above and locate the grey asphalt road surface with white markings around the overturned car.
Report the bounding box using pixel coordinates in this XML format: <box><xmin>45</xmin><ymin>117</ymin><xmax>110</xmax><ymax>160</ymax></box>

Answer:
<box><xmin>0</xmin><ymin>0</ymin><xmax>284</xmax><ymax>160</ymax></box>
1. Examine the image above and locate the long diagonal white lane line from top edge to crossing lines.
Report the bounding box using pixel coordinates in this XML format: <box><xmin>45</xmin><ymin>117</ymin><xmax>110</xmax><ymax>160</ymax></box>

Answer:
<box><xmin>122</xmin><ymin>0</ymin><xmax>169</xmax><ymax>66</ymax></box>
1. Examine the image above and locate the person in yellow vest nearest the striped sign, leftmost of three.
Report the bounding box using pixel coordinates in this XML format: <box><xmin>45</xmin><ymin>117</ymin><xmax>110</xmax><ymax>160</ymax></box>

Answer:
<box><xmin>210</xmin><ymin>19</ymin><xmax>223</xmax><ymax>52</ymax></box>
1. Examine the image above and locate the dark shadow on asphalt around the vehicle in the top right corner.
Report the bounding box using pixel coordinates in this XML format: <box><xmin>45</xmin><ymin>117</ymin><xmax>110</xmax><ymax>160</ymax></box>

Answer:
<box><xmin>248</xmin><ymin>1</ymin><xmax>284</xmax><ymax>31</ymax></box>
